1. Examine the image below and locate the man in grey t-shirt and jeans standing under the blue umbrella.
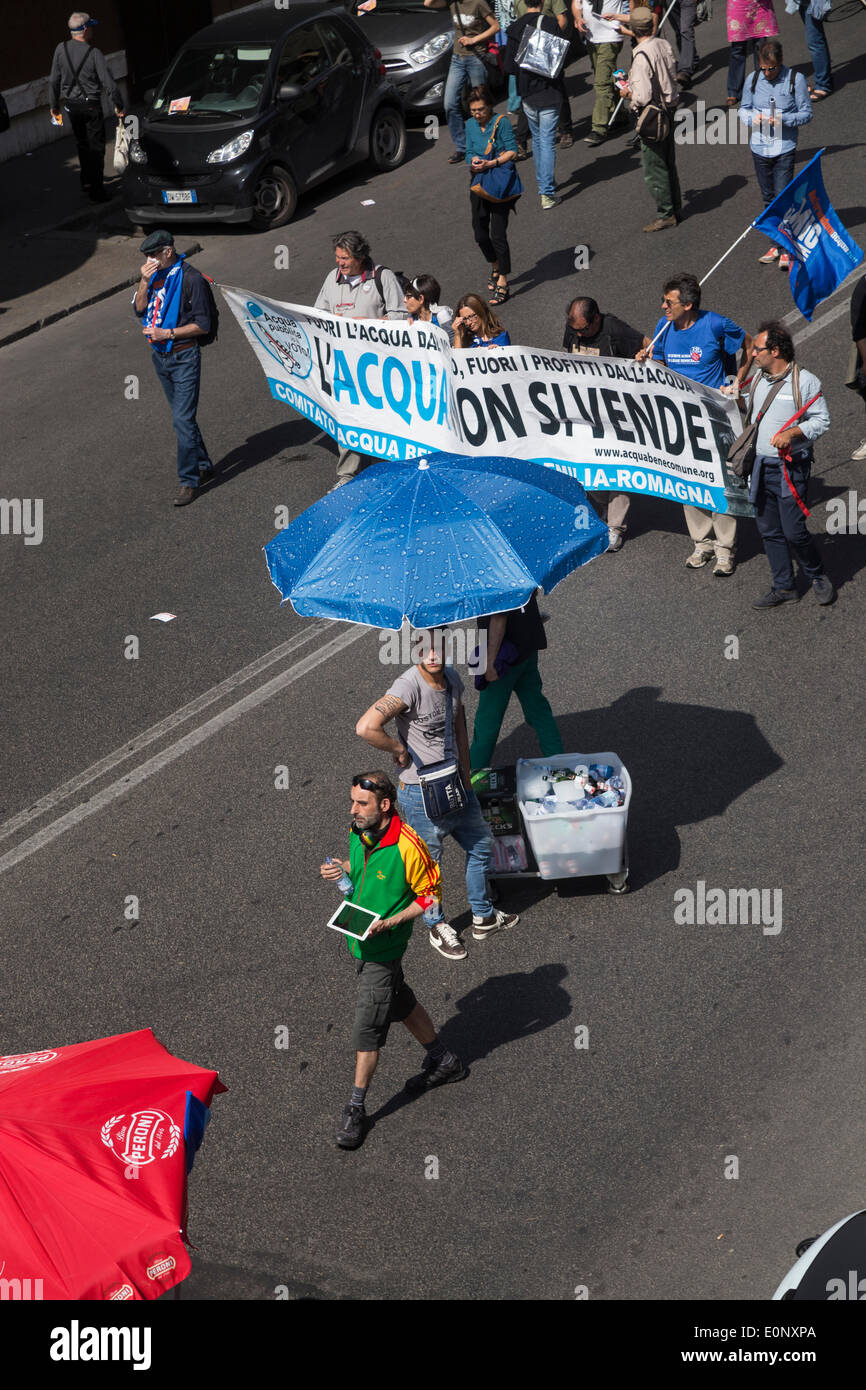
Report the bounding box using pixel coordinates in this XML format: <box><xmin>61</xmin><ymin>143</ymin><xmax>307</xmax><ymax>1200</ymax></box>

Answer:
<box><xmin>354</xmin><ymin>630</ymin><xmax>518</xmax><ymax>960</ymax></box>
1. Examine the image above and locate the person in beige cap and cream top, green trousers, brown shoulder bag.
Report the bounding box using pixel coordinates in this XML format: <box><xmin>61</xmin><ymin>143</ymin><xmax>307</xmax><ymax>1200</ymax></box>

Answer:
<box><xmin>628</xmin><ymin>7</ymin><xmax>683</xmax><ymax>232</ymax></box>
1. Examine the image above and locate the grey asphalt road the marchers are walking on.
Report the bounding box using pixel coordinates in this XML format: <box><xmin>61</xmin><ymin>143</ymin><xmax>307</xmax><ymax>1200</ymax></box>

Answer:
<box><xmin>0</xmin><ymin>4</ymin><xmax>866</xmax><ymax>1301</ymax></box>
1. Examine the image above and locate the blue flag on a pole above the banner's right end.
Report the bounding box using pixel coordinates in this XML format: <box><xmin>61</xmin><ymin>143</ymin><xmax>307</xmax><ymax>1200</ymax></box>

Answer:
<box><xmin>752</xmin><ymin>150</ymin><xmax>863</xmax><ymax>318</ymax></box>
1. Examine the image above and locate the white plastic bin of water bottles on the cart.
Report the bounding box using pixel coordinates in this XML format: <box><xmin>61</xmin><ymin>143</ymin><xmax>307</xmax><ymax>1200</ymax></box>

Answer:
<box><xmin>517</xmin><ymin>753</ymin><xmax>631</xmax><ymax>878</ymax></box>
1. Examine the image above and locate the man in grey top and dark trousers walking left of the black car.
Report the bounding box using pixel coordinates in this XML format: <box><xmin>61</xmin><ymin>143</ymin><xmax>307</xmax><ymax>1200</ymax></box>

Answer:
<box><xmin>49</xmin><ymin>10</ymin><xmax>124</xmax><ymax>203</ymax></box>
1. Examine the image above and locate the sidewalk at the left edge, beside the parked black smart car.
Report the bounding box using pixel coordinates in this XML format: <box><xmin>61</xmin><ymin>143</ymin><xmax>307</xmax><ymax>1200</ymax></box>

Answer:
<box><xmin>0</xmin><ymin>136</ymin><xmax>202</xmax><ymax>348</ymax></box>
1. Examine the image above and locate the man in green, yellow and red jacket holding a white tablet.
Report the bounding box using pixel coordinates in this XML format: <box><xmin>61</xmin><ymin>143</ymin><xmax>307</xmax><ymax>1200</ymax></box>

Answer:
<box><xmin>320</xmin><ymin>771</ymin><xmax>466</xmax><ymax>1148</ymax></box>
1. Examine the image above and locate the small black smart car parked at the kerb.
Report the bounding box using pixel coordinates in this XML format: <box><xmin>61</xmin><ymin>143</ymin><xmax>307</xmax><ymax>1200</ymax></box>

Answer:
<box><xmin>122</xmin><ymin>0</ymin><xmax>406</xmax><ymax>231</ymax></box>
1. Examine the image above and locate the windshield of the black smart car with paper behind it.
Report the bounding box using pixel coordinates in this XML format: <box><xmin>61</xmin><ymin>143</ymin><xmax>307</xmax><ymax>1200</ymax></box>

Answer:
<box><xmin>150</xmin><ymin>43</ymin><xmax>271</xmax><ymax>118</ymax></box>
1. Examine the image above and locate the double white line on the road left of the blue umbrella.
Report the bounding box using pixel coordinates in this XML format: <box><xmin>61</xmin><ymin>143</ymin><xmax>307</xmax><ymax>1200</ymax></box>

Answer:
<box><xmin>0</xmin><ymin>623</ymin><xmax>370</xmax><ymax>873</ymax></box>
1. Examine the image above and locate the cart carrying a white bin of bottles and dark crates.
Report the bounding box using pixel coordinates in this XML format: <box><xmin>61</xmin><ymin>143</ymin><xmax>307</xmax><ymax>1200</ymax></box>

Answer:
<box><xmin>473</xmin><ymin>752</ymin><xmax>631</xmax><ymax>892</ymax></box>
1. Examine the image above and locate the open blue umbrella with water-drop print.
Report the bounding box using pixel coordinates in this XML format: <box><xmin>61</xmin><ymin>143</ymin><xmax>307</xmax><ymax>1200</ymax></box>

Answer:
<box><xmin>264</xmin><ymin>453</ymin><xmax>609</xmax><ymax>631</ymax></box>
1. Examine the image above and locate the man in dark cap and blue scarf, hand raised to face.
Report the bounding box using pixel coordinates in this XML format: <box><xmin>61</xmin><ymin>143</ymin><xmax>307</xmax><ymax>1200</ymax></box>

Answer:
<box><xmin>132</xmin><ymin>228</ymin><xmax>214</xmax><ymax>507</ymax></box>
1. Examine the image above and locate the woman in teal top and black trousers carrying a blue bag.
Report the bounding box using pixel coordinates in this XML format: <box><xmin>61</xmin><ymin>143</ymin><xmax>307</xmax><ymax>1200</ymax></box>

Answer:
<box><xmin>466</xmin><ymin>86</ymin><xmax>517</xmax><ymax>306</ymax></box>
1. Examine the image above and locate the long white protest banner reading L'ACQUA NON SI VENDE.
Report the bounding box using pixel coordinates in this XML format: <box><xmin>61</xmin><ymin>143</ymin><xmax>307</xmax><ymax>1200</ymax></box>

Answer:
<box><xmin>220</xmin><ymin>285</ymin><xmax>751</xmax><ymax>514</ymax></box>
